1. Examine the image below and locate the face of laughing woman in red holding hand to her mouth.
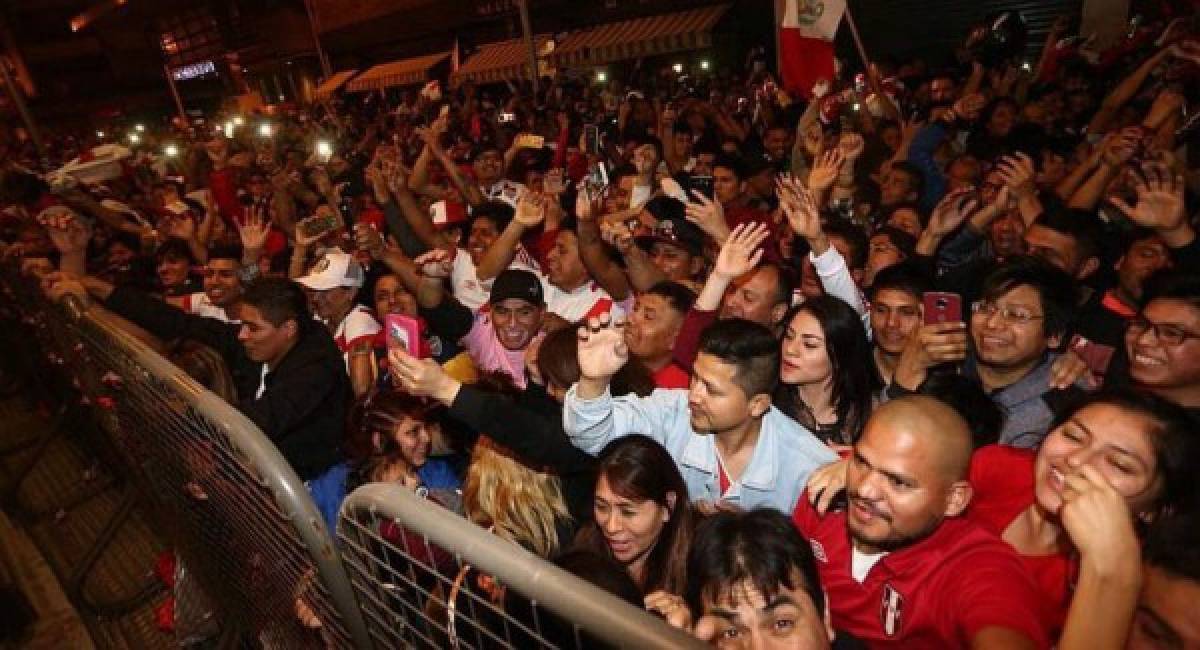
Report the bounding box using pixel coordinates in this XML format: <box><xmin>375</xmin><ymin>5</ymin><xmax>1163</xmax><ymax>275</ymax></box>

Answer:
<box><xmin>1034</xmin><ymin>404</ymin><xmax>1162</xmax><ymax>514</ymax></box>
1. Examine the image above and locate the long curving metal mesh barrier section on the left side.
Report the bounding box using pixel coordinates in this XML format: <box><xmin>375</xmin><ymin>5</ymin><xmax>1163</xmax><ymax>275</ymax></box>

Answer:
<box><xmin>4</xmin><ymin>262</ymin><xmax>370</xmax><ymax>648</ymax></box>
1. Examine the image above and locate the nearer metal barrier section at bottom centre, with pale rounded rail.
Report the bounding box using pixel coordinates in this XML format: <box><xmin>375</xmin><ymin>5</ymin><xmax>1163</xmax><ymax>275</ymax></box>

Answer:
<box><xmin>337</xmin><ymin>483</ymin><xmax>704</xmax><ymax>649</ymax></box>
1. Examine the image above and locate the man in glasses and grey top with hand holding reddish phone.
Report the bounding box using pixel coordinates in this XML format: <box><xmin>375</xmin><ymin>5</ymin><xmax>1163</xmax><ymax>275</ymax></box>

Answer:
<box><xmin>888</xmin><ymin>257</ymin><xmax>1078</xmax><ymax>447</ymax></box>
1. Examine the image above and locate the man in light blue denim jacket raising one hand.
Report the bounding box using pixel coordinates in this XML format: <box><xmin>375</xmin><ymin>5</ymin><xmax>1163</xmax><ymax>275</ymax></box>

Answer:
<box><xmin>563</xmin><ymin>315</ymin><xmax>834</xmax><ymax>512</ymax></box>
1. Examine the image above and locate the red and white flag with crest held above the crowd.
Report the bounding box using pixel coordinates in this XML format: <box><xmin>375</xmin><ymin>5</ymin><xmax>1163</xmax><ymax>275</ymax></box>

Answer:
<box><xmin>776</xmin><ymin>0</ymin><xmax>846</xmax><ymax>98</ymax></box>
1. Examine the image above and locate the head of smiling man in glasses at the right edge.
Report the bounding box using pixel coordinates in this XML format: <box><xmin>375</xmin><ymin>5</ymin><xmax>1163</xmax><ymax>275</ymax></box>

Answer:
<box><xmin>1126</xmin><ymin>273</ymin><xmax>1200</xmax><ymax>416</ymax></box>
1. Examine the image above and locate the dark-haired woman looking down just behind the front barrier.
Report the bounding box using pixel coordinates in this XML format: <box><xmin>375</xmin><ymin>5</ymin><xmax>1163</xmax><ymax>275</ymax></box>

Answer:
<box><xmin>576</xmin><ymin>435</ymin><xmax>696</xmax><ymax>594</ymax></box>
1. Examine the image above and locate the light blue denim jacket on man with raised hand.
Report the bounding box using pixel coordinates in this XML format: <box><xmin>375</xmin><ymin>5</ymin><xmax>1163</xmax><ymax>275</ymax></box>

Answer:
<box><xmin>563</xmin><ymin>386</ymin><xmax>836</xmax><ymax>514</ymax></box>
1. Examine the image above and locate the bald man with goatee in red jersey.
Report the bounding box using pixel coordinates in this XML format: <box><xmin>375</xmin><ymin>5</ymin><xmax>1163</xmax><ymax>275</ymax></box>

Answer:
<box><xmin>792</xmin><ymin>396</ymin><xmax>1049</xmax><ymax>649</ymax></box>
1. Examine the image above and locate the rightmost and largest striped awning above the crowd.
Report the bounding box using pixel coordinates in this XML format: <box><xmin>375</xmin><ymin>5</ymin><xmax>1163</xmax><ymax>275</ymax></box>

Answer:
<box><xmin>550</xmin><ymin>5</ymin><xmax>730</xmax><ymax>67</ymax></box>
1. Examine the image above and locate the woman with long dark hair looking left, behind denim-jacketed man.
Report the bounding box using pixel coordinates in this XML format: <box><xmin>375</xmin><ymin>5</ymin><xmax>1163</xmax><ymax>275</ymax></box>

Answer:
<box><xmin>775</xmin><ymin>296</ymin><xmax>882</xmax><ymax>445</ymax></box>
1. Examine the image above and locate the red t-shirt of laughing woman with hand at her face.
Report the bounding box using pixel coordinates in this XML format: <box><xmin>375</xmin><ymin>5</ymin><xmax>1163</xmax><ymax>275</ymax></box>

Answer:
<box><xmin>966</xmin><ymin>445</ymin><xmax>1079</xmax><ymax>638</ymax></box>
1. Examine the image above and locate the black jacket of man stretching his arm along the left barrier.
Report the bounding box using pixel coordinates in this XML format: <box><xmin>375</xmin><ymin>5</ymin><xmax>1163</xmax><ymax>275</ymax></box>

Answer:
<box><xmin>106</xmin><ymin>287</ymin><xmax>350</xmax><ymax>481</ymax></box>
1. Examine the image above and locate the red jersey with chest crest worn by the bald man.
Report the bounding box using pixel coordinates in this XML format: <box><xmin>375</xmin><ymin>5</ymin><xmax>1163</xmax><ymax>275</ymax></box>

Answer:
<box><xmin>792</xmin><ymin>494</ymin><xmax>1050</xmax><ymax>649</ymax></box>
